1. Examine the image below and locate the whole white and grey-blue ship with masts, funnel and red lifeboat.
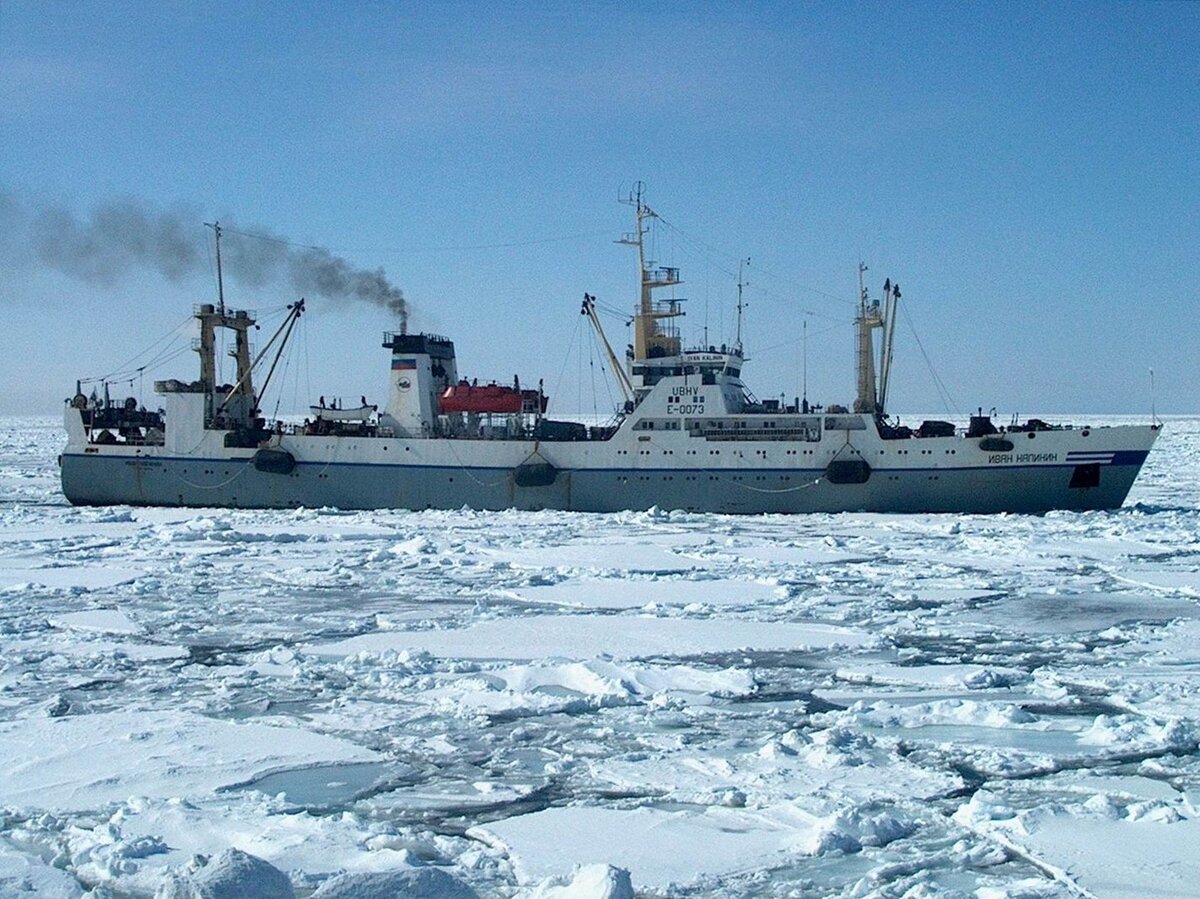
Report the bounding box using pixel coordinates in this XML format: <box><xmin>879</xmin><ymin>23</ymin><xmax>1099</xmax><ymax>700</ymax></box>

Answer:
<box><xmin>60</xmin><ymin>188</ymin><xmax>1160</xmax><ymax>514</ymax></box>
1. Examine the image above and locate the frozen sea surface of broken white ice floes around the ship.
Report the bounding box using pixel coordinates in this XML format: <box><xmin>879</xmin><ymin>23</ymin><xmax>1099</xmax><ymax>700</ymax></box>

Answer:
<box><xmin>0</xmin><ymin>419</ymin><xmax>1200</xmax><ymax>899</ymax></box>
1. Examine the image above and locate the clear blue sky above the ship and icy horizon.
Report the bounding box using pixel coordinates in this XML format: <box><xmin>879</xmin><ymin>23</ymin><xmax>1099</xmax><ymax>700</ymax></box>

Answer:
<box><xmin>0</xmin><ymin>0</ymin><xmax>1200</xmax><ymax>416</ymax></box>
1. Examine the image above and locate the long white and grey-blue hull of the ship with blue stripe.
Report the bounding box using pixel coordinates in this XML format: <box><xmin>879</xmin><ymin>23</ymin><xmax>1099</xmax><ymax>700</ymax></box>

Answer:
<box><xmin>62</xmin><ymin>409</ymin><xmax>1158</xmax><ymax>514</ymax></box>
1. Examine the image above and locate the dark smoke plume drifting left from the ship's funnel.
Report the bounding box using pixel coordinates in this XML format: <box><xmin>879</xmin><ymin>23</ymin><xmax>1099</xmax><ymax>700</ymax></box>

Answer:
<box><xmin>0</xmin><ymin>192</ymin><xmax>408</xmax><ymax>330</ymax></box>
